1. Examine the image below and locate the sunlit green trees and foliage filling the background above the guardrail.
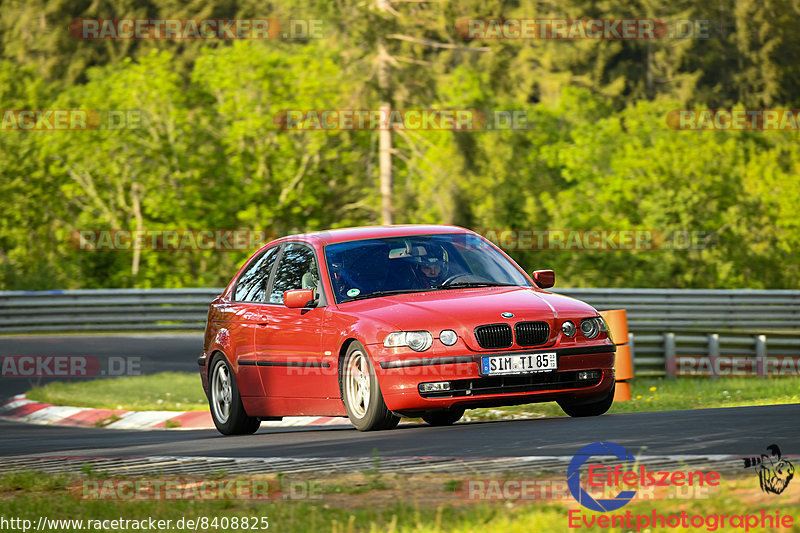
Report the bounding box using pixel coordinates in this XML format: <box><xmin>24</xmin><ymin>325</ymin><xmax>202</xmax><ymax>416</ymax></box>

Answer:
<box><xmin>0</xmin><ymin>0</ymin><xmax>800</xmax><ymax>290</ymax></box>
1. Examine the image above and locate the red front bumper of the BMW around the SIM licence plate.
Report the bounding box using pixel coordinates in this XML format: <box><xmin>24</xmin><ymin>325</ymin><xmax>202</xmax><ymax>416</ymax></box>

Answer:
<box><xmin>368</xmin><ymin>343</ymin><xmax>616</xmax><ymax>414</ymax></box>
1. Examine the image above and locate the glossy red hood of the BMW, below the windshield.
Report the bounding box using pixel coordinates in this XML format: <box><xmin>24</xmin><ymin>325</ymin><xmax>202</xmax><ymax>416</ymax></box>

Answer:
<box><xmin>341</xmin><ymin>287</ymin><xmax>597</xmax><ymax>350</ymax></box>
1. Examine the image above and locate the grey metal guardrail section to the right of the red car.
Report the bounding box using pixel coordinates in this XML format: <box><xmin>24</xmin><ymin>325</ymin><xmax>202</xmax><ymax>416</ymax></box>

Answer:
<box><xmin>553</xmin><ymin>289</ymin><xmax>800</xmax><ymax>376</ymax></box>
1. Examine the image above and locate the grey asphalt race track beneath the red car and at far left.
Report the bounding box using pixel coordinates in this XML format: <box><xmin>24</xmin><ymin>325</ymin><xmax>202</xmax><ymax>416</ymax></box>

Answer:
<box><xmin>0</xmin><ymin>335</ymin><xmax>800</xmax><ymax>458</ymax></box>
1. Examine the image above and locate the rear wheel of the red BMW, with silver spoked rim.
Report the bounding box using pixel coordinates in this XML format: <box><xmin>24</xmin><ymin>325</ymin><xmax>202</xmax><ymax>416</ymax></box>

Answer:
<box><xmin>208</xmin><ymin>355</ymin><xmax>261</xmax><ymax>435</ymax></box>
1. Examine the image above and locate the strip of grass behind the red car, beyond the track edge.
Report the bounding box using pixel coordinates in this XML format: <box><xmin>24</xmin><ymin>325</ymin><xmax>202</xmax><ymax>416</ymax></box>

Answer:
<box><xmin>21</xmin><ymin>372</ymin><xmax>800</xmax><ymax>420</ymax></box>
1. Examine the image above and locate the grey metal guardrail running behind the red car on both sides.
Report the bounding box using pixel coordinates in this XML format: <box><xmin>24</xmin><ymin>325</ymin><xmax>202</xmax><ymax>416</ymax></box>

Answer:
<box><xmin>0</xmin><ymin>289</ymin><xmax>800</xmax><ymax>376</ymax></box>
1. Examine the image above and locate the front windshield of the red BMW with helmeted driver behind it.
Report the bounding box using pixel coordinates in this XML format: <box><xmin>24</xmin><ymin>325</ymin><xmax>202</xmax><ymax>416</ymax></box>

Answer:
<box><xmin>325</xmin><ymin>234</ymin><xmax>531</xmax><ymax>303</ymax></box>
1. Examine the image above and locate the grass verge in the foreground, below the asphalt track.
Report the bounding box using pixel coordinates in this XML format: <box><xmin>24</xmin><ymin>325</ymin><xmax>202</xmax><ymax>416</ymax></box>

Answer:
<box><xmin>0</xmin><ymin>472</ymin><xmax>800</xmax><ymax>533</ymax></box>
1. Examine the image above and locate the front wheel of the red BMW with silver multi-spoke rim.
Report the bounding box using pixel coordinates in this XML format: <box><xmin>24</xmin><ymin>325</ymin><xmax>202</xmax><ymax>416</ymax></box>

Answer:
<box><xmin>342</xmin><ymin>342</ymin><xmax>400</xmax><ymax>431</ymax></box>
